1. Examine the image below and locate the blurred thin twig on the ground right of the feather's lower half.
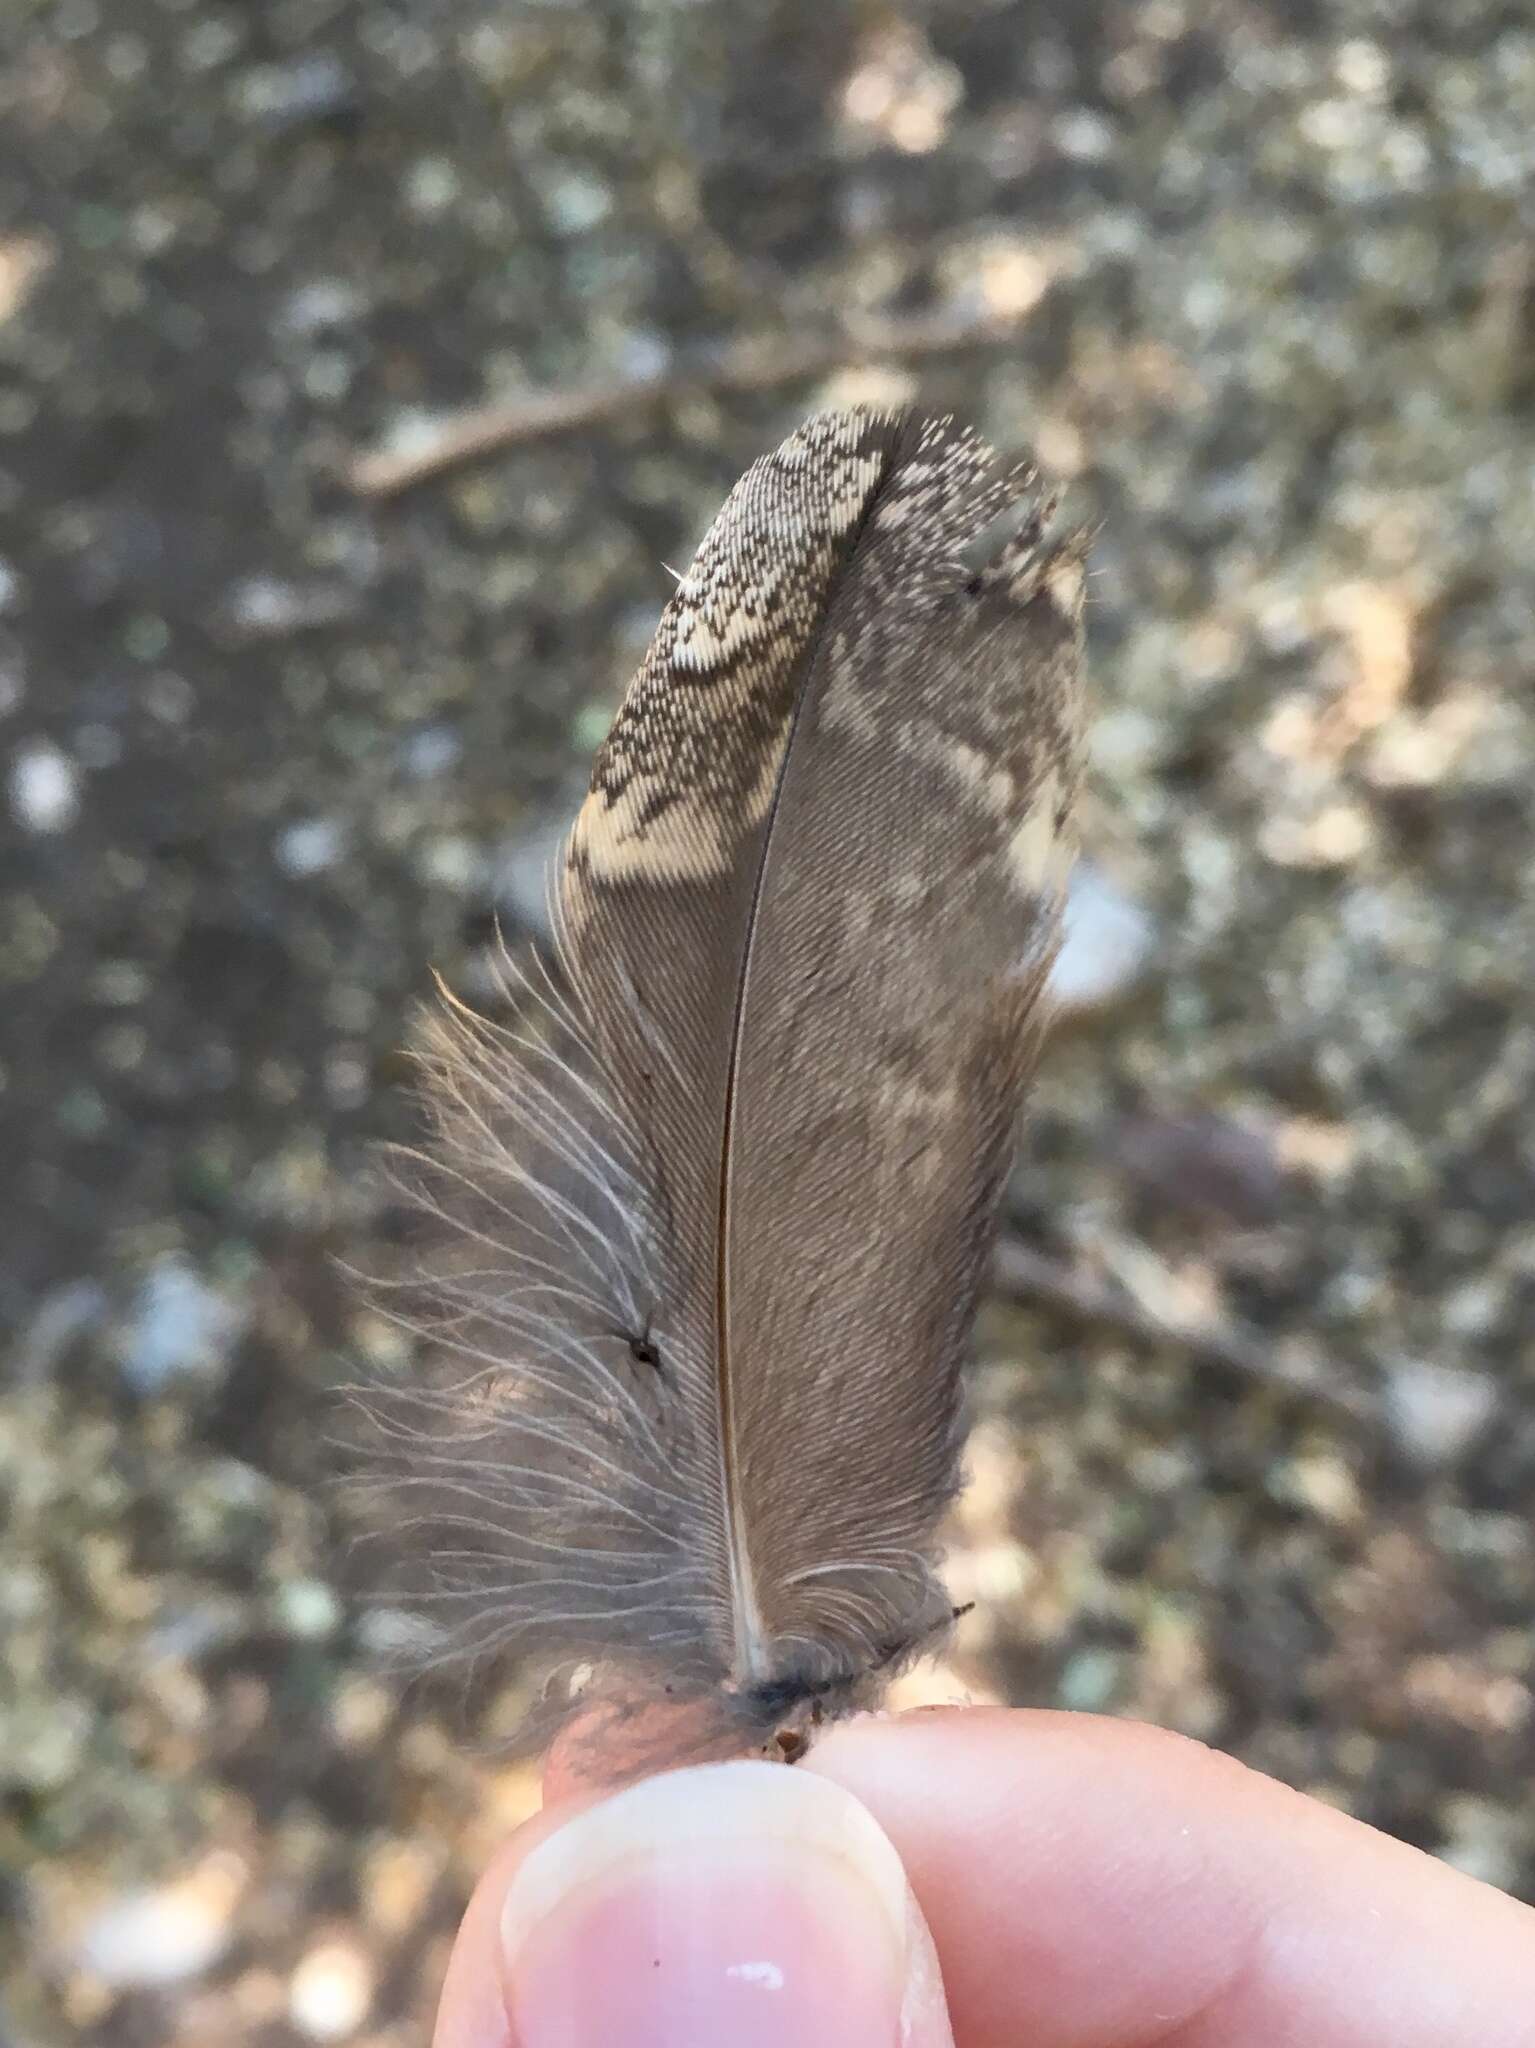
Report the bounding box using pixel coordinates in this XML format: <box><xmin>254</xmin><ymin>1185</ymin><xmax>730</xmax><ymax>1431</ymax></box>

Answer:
<box><xmin>991</xmin><ymin>1237</ymin><xmax>1382</xmax><ymax>1430</ymax></box>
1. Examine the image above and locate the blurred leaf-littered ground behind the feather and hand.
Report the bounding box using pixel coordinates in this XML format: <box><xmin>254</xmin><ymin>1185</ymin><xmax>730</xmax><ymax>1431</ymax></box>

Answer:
<box><xmin>0</xmin><ymin>0</ymin><xmax>1535</xmax><ymax>2048</ymax></box>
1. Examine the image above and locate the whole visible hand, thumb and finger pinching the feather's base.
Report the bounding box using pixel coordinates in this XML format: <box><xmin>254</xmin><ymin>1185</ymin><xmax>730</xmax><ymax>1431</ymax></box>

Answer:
<box><xmin>434</xmin><ymin>1708</ymin><xmax>1535</xmax><ymax>2048</ymax></box>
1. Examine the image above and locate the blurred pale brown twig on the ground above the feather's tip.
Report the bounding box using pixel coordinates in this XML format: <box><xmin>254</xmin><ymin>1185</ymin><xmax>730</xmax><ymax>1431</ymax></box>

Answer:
<box><xmin>346</xmin><ymin>313</ymin><xmax>1035</xmax><ymax>498</ymax></box>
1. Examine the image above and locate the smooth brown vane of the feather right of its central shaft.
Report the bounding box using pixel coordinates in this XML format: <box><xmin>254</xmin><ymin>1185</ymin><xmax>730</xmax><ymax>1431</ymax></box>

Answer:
<box><xmin>722</xmin><ymin>422</ymin><xmax>1081</xmax><ymax>1677</ymax></box>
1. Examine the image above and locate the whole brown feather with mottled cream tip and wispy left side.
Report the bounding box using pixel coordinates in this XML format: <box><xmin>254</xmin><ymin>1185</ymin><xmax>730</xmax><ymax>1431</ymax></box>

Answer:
<box><xmin>356</xmin><ymin>412</ymin><xmax>1083</xmax><ymax>1749</ymax></box>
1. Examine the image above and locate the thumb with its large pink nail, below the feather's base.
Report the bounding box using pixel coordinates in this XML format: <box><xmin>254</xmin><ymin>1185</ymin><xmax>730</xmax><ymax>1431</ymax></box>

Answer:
<box><xmin>434</xmin><ymin>1763</ymin><xmax>954</xmax><ymax>2048</ymax></box>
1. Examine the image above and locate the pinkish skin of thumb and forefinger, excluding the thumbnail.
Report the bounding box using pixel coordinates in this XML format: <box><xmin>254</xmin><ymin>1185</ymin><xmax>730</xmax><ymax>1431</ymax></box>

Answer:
<box><xmin>434</xmin><ymin>1708</ymin><xmax>1535</xmax><ymax>2048</ymax></box>
